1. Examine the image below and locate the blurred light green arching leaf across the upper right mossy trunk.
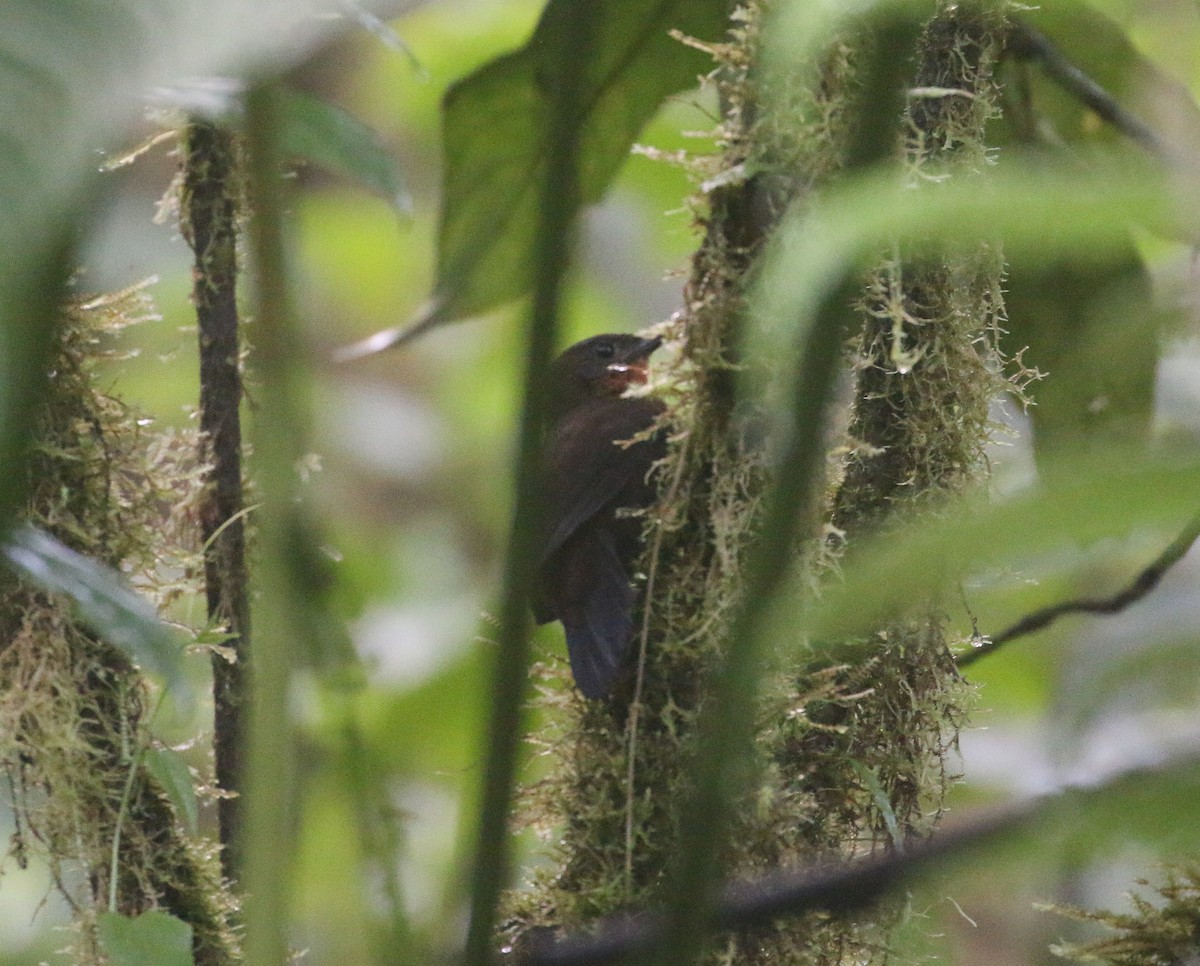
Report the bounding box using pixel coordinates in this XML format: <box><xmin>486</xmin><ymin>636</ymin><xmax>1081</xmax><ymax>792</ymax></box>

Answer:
<box><xmin>752</xmin><ymin>155</ymin><xmax>1181</xmax><ymax>386</ymax></box>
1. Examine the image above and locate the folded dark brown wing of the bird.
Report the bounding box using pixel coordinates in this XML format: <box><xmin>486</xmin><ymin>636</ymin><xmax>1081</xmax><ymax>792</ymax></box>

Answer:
<box><xmin>539</xmin><ymin>398</ymin><xmax>666</xmax><ymax>563</ymax></box>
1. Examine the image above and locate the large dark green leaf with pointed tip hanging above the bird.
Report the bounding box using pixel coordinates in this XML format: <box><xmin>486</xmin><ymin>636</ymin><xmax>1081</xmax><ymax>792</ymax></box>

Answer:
<box><xmin>427</xmin><ymin>0</ymin><xmax>728</xmax><ymax>324</ymax></box>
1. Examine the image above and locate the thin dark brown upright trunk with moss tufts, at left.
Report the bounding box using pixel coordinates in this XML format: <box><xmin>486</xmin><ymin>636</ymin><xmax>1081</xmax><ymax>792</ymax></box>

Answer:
<box><xmin>184</xmin><ymin>121</ymin><xmax>250</xmax><ymax>881</ymax></box>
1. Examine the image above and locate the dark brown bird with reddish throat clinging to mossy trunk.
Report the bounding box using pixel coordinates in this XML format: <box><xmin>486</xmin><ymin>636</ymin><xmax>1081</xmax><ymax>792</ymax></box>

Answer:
<box><xmin>533</xmin><ymin>335</ymin><xmax>666</xmax><ymax>698</ymax></box>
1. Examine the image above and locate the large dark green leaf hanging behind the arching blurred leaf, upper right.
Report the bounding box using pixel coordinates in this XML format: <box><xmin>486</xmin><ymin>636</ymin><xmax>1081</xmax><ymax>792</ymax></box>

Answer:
<box><xmin>991</xmin><ymin>0</ymin><xmax>1200</xmax><ymax>461</ymax></box>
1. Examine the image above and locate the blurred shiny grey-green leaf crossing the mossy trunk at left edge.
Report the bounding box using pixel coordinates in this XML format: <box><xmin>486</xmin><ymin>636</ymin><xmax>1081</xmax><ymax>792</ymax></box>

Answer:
<box><xmin>0</xmin><ymin>526</ymin><xmax>186</xmax><ymax>695</ymax></box>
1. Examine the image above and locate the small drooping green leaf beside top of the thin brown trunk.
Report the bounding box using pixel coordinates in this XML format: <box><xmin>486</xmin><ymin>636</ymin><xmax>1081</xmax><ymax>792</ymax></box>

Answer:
<box><xmin>280</xmin><ymin>89</ymin><xmax>412</xmax><ymax>212</ymax></box>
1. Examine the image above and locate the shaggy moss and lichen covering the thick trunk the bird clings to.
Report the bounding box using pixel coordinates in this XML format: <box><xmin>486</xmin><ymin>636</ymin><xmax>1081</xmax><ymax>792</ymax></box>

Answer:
<box><xmin>509</xmin><ymin>0</ymin><xmax>1003</xmax><ymax>964</ymax></box>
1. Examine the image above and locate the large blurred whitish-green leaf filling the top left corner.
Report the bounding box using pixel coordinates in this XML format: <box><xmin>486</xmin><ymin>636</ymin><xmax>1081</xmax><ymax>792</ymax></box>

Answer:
<box><xmin>0</xmin><ymin>0</ymin><xmax>379</xmax><ymax>516</ymax></box>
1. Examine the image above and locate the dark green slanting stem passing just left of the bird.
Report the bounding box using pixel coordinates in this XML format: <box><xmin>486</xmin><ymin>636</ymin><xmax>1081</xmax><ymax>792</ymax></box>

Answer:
<box><xmin>464</xmin><ymin>7</ymin><xmax>595</xmax><ymax>966</ymax></box>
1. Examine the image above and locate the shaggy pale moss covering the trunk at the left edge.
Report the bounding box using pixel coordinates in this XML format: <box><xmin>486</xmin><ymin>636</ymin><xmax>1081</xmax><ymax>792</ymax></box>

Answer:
<box><xmin>0</xmin><ymin>290</ymin><xmax>236</xmax><ymax>966</ymax></box>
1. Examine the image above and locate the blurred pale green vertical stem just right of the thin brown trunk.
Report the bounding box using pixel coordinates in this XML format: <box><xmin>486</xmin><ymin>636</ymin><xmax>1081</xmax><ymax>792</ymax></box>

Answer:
<box><xmin>241</xmin><ymin>82</ymin><xmax>307</xmax><ymax>966</ymax></box>
